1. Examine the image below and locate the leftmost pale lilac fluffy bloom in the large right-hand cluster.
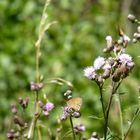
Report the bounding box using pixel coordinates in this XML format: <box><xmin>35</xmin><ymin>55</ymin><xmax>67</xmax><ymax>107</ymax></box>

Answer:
<box><xmin>84</xmin><ymin>66</ymin><xmax>96</xmax><ymax>80</ymax></box>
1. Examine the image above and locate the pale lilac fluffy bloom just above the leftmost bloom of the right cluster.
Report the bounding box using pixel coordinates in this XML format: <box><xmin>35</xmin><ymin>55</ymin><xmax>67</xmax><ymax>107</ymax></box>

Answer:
<box><xmin>93</xmin><ymin>56</ymin><xmax>105</xmax><ymax>70</ymax></box>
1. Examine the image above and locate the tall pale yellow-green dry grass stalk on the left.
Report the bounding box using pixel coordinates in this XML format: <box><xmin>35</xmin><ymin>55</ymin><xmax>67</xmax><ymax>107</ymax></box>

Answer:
<box><xmin>27</xmin><ymin>0</ymin><xmax>52</xmax><ymax>139</ymax></box>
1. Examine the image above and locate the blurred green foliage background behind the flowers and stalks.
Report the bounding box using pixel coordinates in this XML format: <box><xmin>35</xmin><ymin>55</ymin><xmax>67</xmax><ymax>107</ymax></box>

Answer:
<box><xmin>0</xmin><ymin>0</ymin><xmax>140</xmax><ymax>140</ymax></box>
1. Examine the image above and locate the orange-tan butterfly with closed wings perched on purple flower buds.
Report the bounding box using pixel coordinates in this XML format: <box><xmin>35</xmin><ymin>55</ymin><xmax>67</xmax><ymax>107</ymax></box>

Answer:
<box><xmin>67</xmin><ymin>97</ymin><xmax>82</xmax><ymax>111</ymax></box>
